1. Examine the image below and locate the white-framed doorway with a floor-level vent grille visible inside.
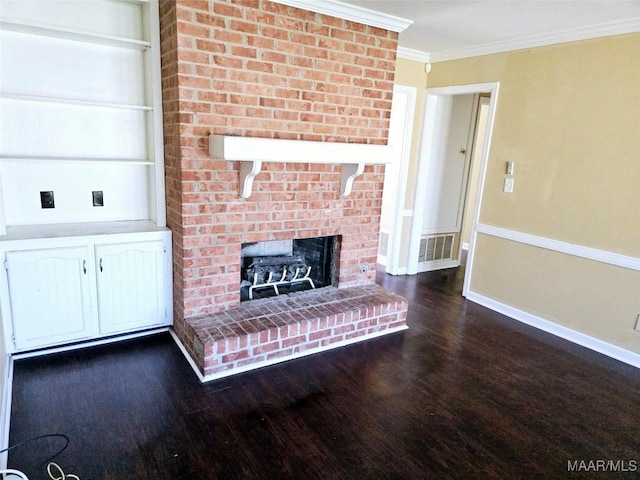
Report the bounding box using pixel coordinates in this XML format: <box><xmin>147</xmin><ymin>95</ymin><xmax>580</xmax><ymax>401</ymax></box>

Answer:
<box><xmin>407</xmin><ymin>83</ymin><xmax>498</xmax><ymax>296</ymax></box>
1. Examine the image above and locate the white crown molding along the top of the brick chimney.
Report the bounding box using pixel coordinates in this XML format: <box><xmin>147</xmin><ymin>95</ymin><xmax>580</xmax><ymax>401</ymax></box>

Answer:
<box><xmin>271</xmin><ymin>0</ymin><xmax>413</xmax><ymax>33</ymax></box>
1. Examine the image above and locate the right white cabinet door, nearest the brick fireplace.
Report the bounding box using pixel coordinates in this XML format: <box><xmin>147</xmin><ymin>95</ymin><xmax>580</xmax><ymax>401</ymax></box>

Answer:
<box><xmin>96</xmin><ymin>240</ymin><xmax>166</xmax><ymax>334</ymax></box>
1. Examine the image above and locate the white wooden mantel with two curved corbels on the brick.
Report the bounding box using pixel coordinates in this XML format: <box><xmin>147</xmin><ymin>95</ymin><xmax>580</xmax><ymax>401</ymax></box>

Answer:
<box><xmin>209</xmin><ymin>135</ymin><xmax>394</xmax><ymax>198</ymax></box>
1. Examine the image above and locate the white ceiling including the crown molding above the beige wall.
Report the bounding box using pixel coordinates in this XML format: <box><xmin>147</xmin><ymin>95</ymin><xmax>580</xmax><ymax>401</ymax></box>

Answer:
<box><xmin>342</xmin><ymin>0</ymin><xmax>640</xmax><ymax>61</ymax></box>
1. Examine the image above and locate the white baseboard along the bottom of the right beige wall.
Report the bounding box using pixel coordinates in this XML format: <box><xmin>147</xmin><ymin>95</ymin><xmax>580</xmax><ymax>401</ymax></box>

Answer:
<box><xmin>467</xmin><ymin>292</ymin><xmax>640</xmax><ymax>368</ymax></box>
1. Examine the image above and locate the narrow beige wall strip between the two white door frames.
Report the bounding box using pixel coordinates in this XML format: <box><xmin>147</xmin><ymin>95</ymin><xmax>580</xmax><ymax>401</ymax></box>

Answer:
<box><xmin>394</xmin><ymin>58</ymin><xmax>427</xmax><ymax>268</ymax></box>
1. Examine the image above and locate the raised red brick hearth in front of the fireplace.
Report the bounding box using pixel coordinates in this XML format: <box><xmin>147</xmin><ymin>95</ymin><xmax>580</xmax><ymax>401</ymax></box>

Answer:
<box><xmin>183</xmin><ymin>285</ymin><xmax>407</xmax><ymax>380</ymax></box>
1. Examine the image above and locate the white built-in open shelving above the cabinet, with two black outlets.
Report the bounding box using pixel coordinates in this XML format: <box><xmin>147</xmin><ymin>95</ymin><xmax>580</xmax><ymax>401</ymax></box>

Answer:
<box><xmin>0</xmin><ymin>0</ymin><xmax>166</xmax><ymax>232</ymax></box>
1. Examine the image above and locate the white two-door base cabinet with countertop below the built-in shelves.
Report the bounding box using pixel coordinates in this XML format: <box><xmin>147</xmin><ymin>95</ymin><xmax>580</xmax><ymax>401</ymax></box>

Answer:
<box><xmin>0</xmin><ymin>221</ymin><xmax>172</xmax><ymax>353</ymax></box>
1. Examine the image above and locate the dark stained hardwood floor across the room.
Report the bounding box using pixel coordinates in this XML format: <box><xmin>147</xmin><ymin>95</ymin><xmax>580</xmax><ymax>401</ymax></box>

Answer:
<box><xmin>9</xmin><ymin>270</ymin><xmax>640</xmax><ymax>480</ymax></box>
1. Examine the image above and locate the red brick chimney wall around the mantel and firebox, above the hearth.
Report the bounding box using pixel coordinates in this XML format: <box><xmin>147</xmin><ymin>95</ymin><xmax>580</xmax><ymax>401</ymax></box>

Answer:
<box><xmin>160</xmin><ymin>0</ymin><xmax>397</xmax><ymax>329</ymax></box>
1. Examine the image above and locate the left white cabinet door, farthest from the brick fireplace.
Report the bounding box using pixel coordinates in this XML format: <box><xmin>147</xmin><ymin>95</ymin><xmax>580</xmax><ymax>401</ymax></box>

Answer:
<box><xmin>6</xmin><ymin>247</ymin><xmax>93</xmax><ymax>350</ymax></box>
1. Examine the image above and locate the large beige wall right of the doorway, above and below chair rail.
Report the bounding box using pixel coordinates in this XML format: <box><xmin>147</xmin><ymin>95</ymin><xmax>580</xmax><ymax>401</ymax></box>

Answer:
<box><xmin>428</xmin><ymin>34</ymin><xmax>640</xmax><ymax>353</ymax></box>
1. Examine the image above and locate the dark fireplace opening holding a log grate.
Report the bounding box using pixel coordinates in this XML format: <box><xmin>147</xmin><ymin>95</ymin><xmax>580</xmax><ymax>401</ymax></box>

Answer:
<box><xmin>240</xmin><ymin>236</ymin><xmax>339</xmax><ymax>301</ymax></box>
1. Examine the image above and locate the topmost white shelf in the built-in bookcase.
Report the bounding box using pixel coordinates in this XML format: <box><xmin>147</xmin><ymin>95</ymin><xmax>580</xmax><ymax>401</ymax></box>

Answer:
<box><xmin>0</xmin><ymin>21</ymin><xmax>151</xmax><ymax>50</ymax></box>
